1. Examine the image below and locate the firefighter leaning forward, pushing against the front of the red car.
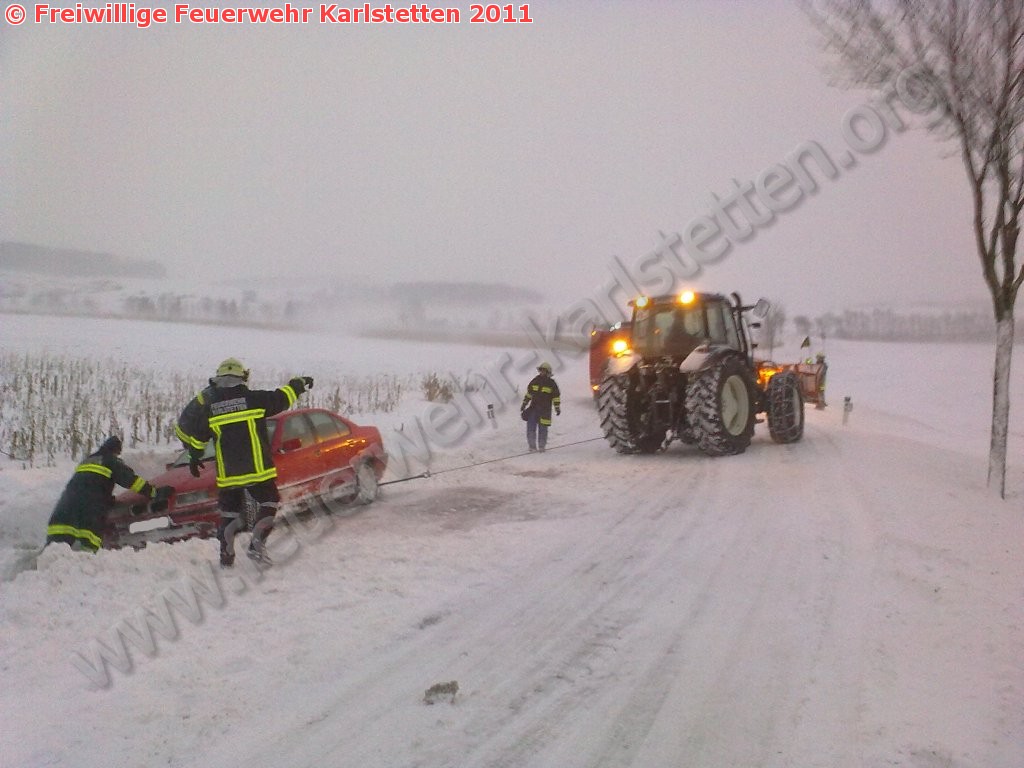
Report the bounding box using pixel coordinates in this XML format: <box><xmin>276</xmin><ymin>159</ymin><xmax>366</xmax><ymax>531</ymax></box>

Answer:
<box><xmin>46</xmin><ymin>435</ymin><xmax>174</xmax><ymax>552</ymax></box>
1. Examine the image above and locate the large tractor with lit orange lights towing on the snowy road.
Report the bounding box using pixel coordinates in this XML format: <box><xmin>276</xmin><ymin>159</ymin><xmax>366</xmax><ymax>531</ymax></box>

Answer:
<box><xmin>597</xmin><ymin>291</ymin><xmax>804</xmax><ymax>456</ymax></box>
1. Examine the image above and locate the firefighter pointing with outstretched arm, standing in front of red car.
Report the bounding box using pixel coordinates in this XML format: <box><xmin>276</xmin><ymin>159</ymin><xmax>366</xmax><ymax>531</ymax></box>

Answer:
<box><xmin>175</xmin><ymin>357</ymin><xmax>313</xmax><ymax>567</ymax></box>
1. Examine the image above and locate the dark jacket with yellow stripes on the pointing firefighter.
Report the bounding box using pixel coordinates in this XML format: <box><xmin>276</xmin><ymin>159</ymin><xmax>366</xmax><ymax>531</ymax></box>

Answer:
<box><xmin>175</xmin><ymin>379</ymin><xmax>305</xmax><ymax>488</ymax></box>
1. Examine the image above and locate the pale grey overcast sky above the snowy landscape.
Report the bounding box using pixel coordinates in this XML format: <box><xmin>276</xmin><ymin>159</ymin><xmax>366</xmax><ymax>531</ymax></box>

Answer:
<box><xmin>0</xmin><ymin>0</ymin><xmax>986</xmax><ymax>316</ymax></box>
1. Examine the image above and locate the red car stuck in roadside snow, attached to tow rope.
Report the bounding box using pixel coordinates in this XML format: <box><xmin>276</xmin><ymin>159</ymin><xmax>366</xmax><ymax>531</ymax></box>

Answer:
<box><xmin>103</xmin><ymin>408</ymin><xmax>387</xmax><ymax>549</ymax></box>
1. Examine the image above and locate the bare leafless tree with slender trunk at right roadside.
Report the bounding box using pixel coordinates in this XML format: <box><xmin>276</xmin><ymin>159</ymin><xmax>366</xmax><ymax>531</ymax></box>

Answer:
<box><xmin>803</xmin><ymin>0</ymin><xmax>1024</xmax><ymax>498</ymax></box>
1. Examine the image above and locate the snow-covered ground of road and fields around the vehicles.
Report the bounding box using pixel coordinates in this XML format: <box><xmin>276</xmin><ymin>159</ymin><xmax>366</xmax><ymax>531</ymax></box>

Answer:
<box><xmin>0</xmin><ymin>316</ymin><xmax>1024</xmax><ymax>768</ymax></box>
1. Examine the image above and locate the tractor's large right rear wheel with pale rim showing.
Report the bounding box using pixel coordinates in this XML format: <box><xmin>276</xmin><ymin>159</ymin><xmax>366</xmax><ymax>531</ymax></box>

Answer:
<box><xmin>686</xmin><ymin>356</ymin><xmax>756</xmax><ymax>456</ymax></box>
